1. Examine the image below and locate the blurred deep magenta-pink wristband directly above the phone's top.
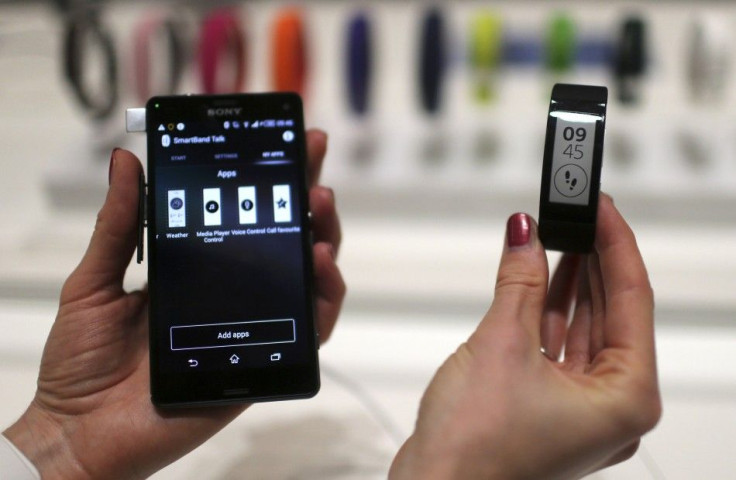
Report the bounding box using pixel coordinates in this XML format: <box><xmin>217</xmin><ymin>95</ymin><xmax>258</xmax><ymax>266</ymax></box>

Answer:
<box><xmin>198</xmin><ymin>8</ymin><xmax>246</xmax><ymax>94</ymax></box>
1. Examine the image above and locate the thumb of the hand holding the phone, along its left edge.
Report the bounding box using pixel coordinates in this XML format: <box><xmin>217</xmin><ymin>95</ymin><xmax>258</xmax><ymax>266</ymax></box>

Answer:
<box><xmin>61</xmin><ymin>149</ymin><xmax>143</xmax><ymax>303</ymax></box>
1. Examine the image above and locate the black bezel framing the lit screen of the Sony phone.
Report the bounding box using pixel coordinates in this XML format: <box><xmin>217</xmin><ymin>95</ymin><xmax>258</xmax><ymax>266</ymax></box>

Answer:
<box><xmin>146</xmin><ymin>93</ymin><xmax>320</xmax><ymax>406</ymax></box>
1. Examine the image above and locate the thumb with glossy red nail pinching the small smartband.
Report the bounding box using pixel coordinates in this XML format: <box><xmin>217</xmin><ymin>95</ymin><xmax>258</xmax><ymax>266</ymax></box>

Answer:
<box><xmin>483</xmin><ymin>213</ymin><xmax>549</xmax><ymax>349</ymax></box>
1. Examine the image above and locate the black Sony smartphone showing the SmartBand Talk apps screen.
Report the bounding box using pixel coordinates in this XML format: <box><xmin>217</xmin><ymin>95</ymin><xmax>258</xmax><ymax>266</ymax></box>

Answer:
<box><xmin>146</xmin><ymin>93</ymin><xmax>320</xmax><ymax>406</ymax></box>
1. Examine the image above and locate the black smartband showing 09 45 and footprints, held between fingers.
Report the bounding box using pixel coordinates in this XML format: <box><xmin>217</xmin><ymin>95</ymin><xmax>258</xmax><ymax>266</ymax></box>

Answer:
<box><xmin>539</xmin><ymin>84</ymin><xmax>608</xmax><ymax>253</ymax></box>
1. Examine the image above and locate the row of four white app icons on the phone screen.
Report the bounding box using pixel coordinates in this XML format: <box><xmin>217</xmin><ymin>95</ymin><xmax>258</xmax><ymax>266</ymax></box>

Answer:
<box><xmin>168</xmin><ymin>185</ymin><xmax>291</xmax><ymax>228</ymax></box>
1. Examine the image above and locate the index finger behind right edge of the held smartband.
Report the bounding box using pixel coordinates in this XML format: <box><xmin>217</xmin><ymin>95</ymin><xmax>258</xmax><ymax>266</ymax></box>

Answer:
<box><xmin>595</xmin><ymin>195</ymin><xmax>654</xmax><ymax>357</ymax></box>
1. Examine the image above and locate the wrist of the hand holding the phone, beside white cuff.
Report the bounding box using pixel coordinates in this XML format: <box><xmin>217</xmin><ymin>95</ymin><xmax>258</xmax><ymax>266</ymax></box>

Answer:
<box><xmin>3</xmin><ymin>404</ymin><xmax>86</xmax><ymax>480</ymax></box>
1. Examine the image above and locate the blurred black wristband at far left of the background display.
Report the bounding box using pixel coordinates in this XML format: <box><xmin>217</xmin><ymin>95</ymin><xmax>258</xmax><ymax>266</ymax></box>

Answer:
<box><xmin>63</xmin><ymin>9</ymin><xmax>118</xmax><ymax>119</ymax></box>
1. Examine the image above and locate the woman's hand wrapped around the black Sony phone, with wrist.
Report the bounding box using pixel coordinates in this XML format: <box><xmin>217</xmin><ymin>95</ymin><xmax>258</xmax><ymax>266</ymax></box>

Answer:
<box><xmin>4</xmin><ymin>130</ymin><xmax>345</xmax><ymax>479</ymax></box>
